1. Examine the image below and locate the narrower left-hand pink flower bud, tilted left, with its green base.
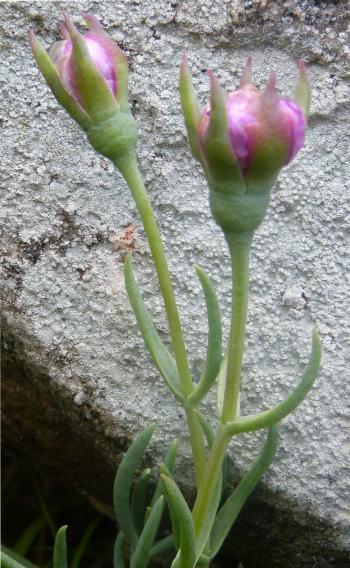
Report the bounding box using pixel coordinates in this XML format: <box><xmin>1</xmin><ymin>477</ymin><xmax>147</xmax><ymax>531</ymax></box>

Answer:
<box><xmin>30</xmin><ymin>14</ymin><xmax>137</xmax><ymax>160</ymax></box>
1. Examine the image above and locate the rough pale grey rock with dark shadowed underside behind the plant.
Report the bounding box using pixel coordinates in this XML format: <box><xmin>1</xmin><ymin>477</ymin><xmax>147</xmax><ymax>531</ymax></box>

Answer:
<box><xmin>0</xmin><ymin>0</ymin><xmax>350</xmax><ymax>568</ymax></box>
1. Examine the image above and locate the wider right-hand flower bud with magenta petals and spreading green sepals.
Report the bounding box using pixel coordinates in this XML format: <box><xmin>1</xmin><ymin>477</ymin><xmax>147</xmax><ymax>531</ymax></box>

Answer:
<box><xmin>180</xmin><ymin>58</ymin><xmax>310</xmax><ymax>232</ymax></box>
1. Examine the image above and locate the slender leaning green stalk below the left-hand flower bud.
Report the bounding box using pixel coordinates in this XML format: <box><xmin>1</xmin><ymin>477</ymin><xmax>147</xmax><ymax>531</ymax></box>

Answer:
<box><xmin>115</xmin><ymin>154</ymin><xmax>205</xmax><ymax>487</ymax></box>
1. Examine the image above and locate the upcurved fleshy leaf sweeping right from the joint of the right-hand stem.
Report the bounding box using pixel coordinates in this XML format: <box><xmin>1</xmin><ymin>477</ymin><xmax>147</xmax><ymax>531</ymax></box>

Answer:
<box><xmin>225</xmin><ymin>328</ymin><xmax>322</xmax><ymax>436</ymax></box>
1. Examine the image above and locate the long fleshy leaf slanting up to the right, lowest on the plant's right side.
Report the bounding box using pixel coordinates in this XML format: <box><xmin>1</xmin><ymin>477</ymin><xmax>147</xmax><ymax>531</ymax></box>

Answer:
<box><xmin>210</xmin><ymin>426</ymin><xmax>278</xmax><ymax>558</ymax></box>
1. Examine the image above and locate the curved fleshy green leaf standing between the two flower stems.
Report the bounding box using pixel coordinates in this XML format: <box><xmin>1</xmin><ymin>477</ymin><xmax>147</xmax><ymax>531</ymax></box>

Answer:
<box><xmin>187</xmin><ymin>265</ymin><xmax>222</xmax><ymax>407</ymax></box>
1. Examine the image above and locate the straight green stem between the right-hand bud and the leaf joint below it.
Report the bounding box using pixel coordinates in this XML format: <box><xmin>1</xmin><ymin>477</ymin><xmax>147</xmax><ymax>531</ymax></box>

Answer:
<box><xmin>221</xmin><ymin>233</ymin><xmax>253</xmax><ymax>424</ymax></box>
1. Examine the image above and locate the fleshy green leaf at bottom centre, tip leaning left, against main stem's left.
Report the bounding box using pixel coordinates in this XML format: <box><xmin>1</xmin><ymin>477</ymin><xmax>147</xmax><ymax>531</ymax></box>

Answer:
<box><xmin>161</xmin><ymin>475</ymin><xmax>196</xmax><ymax>568</ymax></box>
